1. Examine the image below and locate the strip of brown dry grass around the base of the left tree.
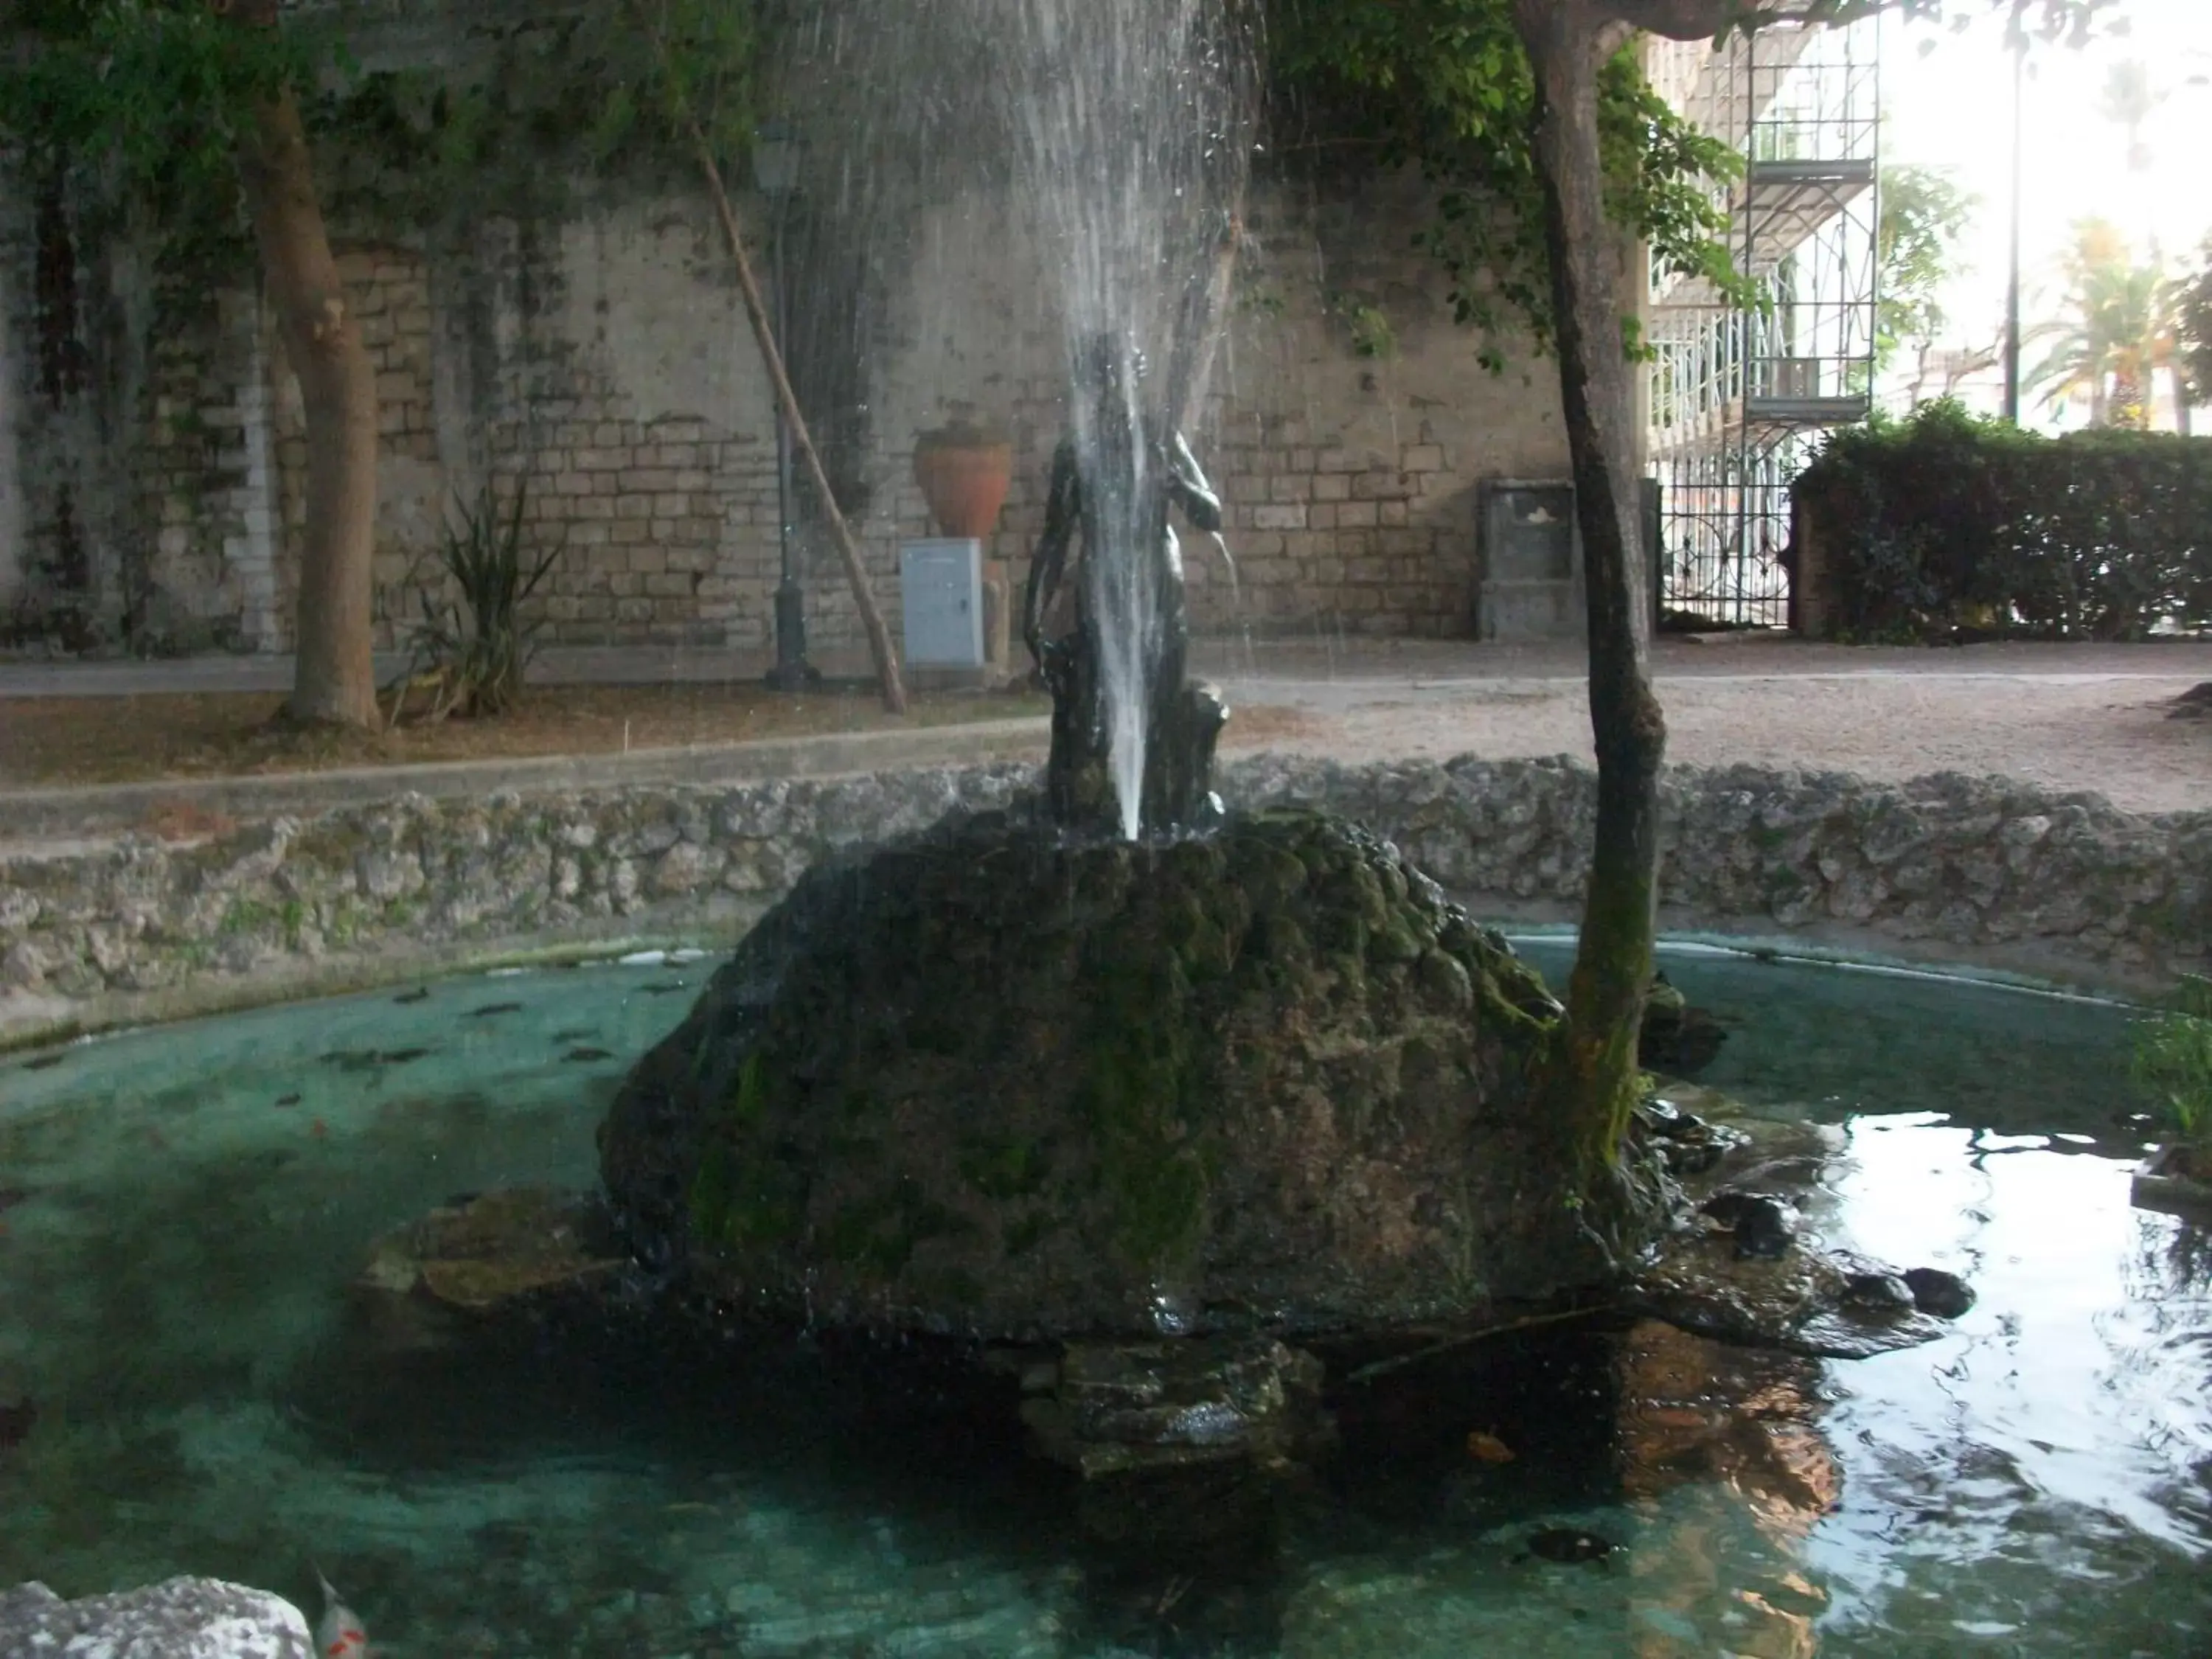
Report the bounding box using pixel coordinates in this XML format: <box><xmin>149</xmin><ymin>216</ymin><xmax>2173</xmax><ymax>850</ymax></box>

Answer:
<box><xmin>0</xmin><ymin>686</ymin><xmax>1051</xmax><ymax>787</ymax></box>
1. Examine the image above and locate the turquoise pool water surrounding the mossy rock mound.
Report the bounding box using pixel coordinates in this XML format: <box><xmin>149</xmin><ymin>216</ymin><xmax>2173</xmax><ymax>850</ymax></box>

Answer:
<box><xmin>0</xmin><ymin>947</ymin><xmax>2212</xmax><ymax>1659</ymax></box>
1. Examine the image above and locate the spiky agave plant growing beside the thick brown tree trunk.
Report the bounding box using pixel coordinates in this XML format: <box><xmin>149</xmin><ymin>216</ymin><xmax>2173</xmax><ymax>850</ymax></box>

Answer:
<box><xmin>392</xmin><ymin>478</ymin><xmax>560</xmax><ymax>723</ymax></box>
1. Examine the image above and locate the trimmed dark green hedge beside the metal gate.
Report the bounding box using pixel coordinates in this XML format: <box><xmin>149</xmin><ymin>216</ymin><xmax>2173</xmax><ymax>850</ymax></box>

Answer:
<box><xmin>1794</xmin><ymin>403</ymin><xmax>2212</xmax><ymax>639</ymax></box>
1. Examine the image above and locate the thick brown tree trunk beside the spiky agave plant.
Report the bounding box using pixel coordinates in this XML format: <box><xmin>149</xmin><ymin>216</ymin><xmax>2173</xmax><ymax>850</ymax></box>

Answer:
<box><xmin>237</xmin><ymin>0</ymin><xmax>376</xmax><ymax>726</ymax></box>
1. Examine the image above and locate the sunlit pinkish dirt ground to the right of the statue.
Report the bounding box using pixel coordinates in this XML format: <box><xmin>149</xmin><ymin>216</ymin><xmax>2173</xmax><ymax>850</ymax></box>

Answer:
<box><xmin>1230</xmin><ymin>672</ymin><xmax>2212</xmax><ymax>812</ymax></box>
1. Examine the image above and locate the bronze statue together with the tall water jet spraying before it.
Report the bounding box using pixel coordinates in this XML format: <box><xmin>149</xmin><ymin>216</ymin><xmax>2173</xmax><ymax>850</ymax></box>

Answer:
<box><xmin>995</xmin><ymin>0</ymin><xmax>1250</xmax><ymax>838</ymax></box>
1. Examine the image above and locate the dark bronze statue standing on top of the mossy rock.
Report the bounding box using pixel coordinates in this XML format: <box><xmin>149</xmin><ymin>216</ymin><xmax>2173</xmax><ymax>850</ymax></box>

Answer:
<box><xmin>1022</xmin><ymin>334</ymin><xmax>1228</xmax><ymax>832</ymax></box>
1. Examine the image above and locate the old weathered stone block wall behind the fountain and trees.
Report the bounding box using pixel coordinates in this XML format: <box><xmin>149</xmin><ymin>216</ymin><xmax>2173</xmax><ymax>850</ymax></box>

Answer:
<box><xmin>0</xmin><ymin>146</ymin><xmax>1593</xmax><ymax>653</ymax></box>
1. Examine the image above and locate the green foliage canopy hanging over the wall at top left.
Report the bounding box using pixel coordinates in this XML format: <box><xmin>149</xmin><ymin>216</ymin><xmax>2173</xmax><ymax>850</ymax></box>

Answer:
<box><xmin>0</xmin><ymin>0</ymin><xmax>761</xmax><ymax>274</ymax></box>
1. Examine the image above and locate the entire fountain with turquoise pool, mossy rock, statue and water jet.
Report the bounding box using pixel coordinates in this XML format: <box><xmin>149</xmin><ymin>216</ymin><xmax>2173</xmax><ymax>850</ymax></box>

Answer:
<box><xmin>0</xmin><ymin>0</ymin><xmax>2205</xmax><ymax>1655</ymax></box>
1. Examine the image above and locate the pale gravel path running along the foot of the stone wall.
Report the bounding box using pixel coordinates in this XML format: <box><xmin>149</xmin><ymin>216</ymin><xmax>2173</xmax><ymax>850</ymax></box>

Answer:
<box><xmin>0</xmin><ymin>635</ymin><xmax>2212</xmax><ymax>812</ymax></box>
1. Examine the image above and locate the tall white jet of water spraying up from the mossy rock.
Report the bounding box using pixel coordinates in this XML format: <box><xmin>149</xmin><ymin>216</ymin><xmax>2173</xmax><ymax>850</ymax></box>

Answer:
<box><xmin>973</xmin><ymin>0</ymin><xmax>1248</xmax><ymax>838</ymax></box>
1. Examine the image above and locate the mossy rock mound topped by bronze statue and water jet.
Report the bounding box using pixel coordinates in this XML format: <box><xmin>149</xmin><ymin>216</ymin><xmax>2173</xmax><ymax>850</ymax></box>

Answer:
<box><xmin>580</xmin><ymin>0</ymin><xmax>1964</xmax><ymax>1566</ymax></box>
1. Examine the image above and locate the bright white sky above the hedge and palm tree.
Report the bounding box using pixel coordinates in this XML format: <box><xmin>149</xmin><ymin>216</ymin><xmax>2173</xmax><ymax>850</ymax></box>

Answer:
<box><xmin>1880</xmin><ymin>0</ymin><xmax>2212</xmax><ymax>416</ymax></box>
